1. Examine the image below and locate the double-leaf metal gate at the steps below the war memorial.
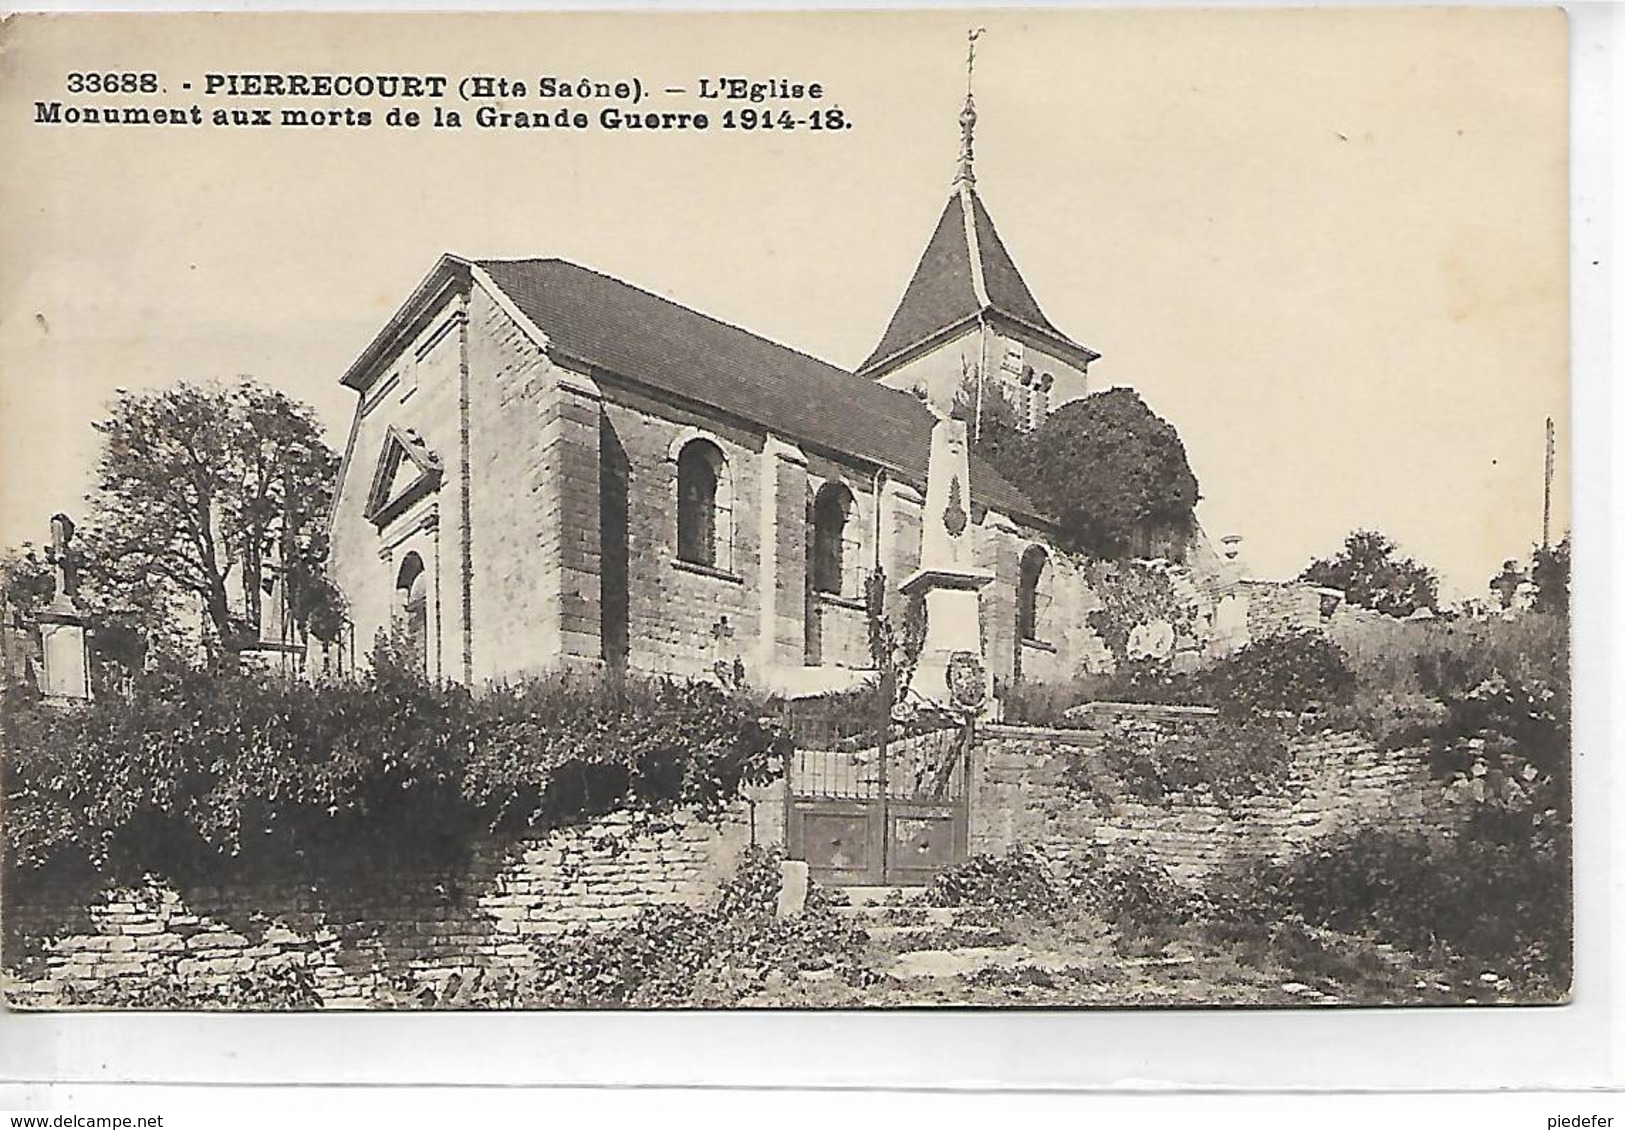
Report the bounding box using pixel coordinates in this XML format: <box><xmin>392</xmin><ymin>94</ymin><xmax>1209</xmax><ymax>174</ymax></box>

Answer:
<box><xmin>787</xmin><ymin>717</ymin><xmax>970</xmax><ymax>884</ymax></box>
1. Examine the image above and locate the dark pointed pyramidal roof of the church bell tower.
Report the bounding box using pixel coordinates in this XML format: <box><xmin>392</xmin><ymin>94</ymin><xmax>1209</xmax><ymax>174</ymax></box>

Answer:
<box><xmin>858</xmin><ymin>187</ymin><xmax>1099</xmax><ymax>376</ymax></box>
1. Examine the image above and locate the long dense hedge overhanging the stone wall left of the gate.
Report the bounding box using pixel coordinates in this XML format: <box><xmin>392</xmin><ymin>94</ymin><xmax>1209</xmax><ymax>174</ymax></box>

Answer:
<box><xmin>5</xmin><ymin>663</ymin><xmax>785</xmax><ymax>878</ymax></box>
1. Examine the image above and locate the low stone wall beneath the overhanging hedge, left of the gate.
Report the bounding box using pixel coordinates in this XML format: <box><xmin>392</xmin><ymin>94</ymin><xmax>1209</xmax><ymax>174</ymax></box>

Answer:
<box><xmin>5</xmin><ymin>790</ymin><xmax>783</xmax><ymax>1008</ymax></box>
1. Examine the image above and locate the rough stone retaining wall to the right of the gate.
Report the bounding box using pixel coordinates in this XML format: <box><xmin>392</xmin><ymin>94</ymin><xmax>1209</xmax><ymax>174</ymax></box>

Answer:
<box><xmin>970</xmin><ymin>704</ymin><xmax>1454</xmax><ymax>884</ymax></box>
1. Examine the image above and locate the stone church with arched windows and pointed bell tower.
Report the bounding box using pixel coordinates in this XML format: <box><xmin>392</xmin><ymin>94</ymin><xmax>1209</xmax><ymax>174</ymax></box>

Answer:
<box><xmin>316</xmin><ymin>77</ymin><xmax>1228</xmax><ymax>691</ymax></box>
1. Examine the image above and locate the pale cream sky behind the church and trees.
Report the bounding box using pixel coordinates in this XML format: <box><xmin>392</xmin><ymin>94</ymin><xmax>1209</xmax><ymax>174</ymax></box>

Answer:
<box><xmin>0</xmin><ymin>10</ymin><xmax>1568</xmax><ymax>592</ymax></box>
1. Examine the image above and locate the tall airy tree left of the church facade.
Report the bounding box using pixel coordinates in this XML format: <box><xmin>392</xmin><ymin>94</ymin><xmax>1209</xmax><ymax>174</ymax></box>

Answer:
<box><xmin>86</xmin><ymin>379</ymin><xmax>338</xmax><ymax>654</ymax></box>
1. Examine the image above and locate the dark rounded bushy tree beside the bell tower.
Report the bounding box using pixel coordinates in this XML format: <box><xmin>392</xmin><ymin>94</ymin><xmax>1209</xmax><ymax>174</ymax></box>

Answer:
<box><xmin>983</xmin><ymin>389</ymin><xmax>1201</xmax><ymax>559</ymax></box>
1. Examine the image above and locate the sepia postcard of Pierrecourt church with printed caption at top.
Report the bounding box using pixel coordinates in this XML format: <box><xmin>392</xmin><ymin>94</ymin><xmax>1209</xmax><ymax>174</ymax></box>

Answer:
<box><xmin>0</xmin><ymin>8</ymin><xmax>1573</xmax><ymax>1010</ymax></box>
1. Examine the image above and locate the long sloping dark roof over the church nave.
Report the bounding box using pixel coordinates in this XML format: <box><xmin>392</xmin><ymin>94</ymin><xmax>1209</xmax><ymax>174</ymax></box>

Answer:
<box><xmin>476</xmin><ymin>259</ymin><xmax>1043</xmax><ymax>520</ymax></box>
